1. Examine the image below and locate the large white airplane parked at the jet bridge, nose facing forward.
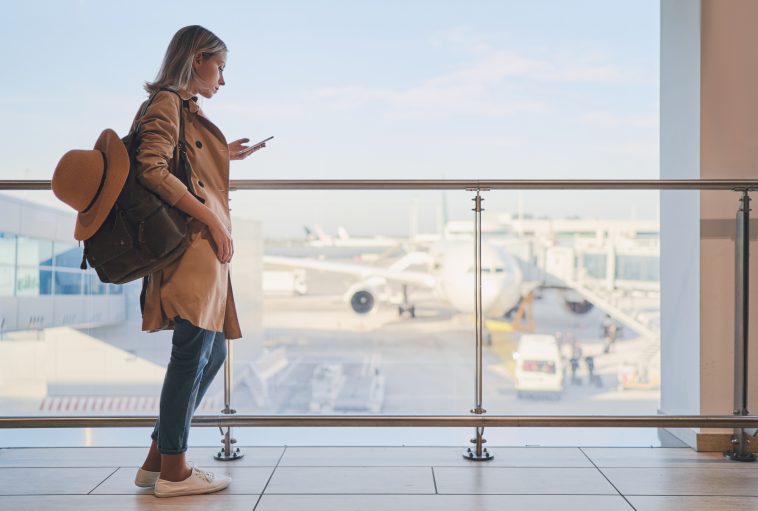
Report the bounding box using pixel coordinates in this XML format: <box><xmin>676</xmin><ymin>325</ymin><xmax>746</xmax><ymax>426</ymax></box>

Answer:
<box><xmin>263</xmin><ymin>241</ymin><xmax>539</xmax><ymax>318</ymax></box>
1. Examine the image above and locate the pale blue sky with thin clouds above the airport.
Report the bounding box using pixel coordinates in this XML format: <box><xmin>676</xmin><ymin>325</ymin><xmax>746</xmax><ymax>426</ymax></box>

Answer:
<box><xmin>0</xmin><ymin>0</ymin><xmax>660</xmax><ymax>238</ymax></box>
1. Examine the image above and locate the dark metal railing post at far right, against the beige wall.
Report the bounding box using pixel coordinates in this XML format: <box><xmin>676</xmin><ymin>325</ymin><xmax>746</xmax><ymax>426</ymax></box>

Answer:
<box><xmin>725</xmin><ymin>190</ymin><xmax>756</xmax><ymax>461</ymax></box>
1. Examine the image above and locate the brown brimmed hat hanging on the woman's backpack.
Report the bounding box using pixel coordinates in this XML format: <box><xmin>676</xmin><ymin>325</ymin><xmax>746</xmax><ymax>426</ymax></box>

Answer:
<box><xmin>53</xmin><ymin>130</ymin><xmax>129</xmax><ymax>240</ymax></box>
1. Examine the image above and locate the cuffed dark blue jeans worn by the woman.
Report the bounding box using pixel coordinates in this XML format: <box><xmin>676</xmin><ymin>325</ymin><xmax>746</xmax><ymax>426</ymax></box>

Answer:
<box><xmin>150</xmin><ymin>317</ymin><xmax>226</xmax><ymax>454</ymax></box>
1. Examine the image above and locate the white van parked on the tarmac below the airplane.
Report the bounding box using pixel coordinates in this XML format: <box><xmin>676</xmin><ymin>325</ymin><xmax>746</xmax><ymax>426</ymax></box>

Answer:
<box><xmin>513</xmin><ymin>334</ymin><xmax>565</xmax><ymax>398</ymax></box>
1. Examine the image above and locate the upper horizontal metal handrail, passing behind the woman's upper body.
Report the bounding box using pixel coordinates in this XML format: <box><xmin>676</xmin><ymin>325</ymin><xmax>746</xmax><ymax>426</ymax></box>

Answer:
<box><xmin>0</xmin><ymin>179</ymin><xmax>758</xmax><ymax>191</ymax></box>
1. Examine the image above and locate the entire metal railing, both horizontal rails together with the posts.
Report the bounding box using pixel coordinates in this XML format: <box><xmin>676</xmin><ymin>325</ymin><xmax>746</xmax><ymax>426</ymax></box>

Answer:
<box><xmin>0</xmin><ymin>179</ymin><xmax>758</xmax><ymax>461</ymax></box>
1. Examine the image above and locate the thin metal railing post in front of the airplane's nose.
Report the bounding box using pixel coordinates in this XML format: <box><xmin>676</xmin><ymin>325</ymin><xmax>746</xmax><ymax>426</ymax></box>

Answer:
<box><xmin>463</xmin><ymin>188</ymin><xmax>494</xmax><ymax>461</ymax></box>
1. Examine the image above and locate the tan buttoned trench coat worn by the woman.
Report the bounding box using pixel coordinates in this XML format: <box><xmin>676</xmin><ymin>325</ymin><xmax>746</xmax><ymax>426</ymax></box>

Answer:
<box><xmin>137</xmin><ymin>91</ymin><xmax>242</xmax><ymax>339</ymax></box>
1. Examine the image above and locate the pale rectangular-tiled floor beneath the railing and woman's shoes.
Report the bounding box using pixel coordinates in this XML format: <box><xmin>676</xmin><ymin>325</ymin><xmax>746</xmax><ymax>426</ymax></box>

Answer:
<box><xmin>0</xmin><ymin>447</ymin><xmax>758</xmax><ymax>511</ymax></box>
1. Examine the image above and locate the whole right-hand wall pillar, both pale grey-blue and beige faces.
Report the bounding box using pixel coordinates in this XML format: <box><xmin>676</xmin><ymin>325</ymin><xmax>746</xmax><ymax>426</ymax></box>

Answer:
<box><xmin>661</xmin><ymin>0</ymin><xmax>758</xmax><ymax>450</ymax></box>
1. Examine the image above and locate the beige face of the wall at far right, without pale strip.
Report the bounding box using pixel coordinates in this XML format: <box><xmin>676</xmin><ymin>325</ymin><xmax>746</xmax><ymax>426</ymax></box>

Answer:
<box><xmin>700</xmin><ymin>0</ymin><xmax>758</xmax><ymax>420</ymax></box>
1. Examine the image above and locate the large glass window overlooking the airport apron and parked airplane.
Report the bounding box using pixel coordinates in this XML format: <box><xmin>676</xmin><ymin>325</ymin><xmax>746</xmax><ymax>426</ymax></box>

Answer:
<box><xmin>0</xmin><ymin>0</ymin><xmax>660</xmax><ymax>445</ymax></box>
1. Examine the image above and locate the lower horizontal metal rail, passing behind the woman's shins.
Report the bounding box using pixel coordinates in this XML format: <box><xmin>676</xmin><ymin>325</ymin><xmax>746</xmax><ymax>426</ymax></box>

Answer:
<box><xmin>0</xmin><ymin>415</ymin><xmax>758</xmax><ymax>429</ymax></box>
